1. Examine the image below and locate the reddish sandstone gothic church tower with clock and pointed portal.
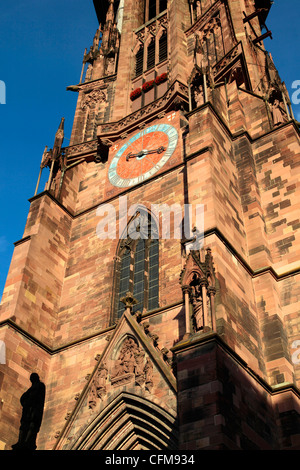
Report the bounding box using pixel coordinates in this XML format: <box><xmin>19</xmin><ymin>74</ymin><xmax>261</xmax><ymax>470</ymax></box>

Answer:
<box><xmin>0</xmin><ymin>0</ymin><xmax>300</xmax><ymax>450</ymax></box>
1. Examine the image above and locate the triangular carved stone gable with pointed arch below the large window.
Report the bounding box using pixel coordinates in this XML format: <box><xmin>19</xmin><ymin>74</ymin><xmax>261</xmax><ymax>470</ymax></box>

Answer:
<box><xmin>56</xmin><ymin>310</ymin><xmax>177</xmax><ymax>450</ymax></box>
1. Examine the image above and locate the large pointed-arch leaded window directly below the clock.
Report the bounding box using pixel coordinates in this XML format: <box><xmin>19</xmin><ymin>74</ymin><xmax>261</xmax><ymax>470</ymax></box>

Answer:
<box><xmin>111</xmin><ymin>210</ymin><xmax>159</xmax><ymax>322</ymax></box>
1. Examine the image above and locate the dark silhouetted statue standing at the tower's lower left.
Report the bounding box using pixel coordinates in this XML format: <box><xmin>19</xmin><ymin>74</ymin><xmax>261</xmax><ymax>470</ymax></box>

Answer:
<box><xmin>12</xmin><ymin>372</ymin><xmax>46</xmax><ymax>450</ymax></box>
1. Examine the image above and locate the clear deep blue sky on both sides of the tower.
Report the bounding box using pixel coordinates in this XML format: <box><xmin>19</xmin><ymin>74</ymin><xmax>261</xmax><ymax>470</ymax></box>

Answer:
<box><xmin>0</xmin><ymin>0</ymin><xmax>300</xmax><ymax>298</ymax></box>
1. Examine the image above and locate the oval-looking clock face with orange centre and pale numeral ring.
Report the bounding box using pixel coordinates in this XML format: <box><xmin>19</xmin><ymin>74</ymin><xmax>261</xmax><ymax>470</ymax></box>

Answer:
<box><xmin>108</xmin><ymin>124</ymin><xmax>178</xmax><ymax>188</ymax></box>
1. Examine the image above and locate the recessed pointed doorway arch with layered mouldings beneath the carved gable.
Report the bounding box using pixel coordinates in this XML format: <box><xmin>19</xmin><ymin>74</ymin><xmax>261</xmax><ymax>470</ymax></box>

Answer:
<box><xmin>69</xmin><ymin>392</ymin><xmax>178</xmax><ymax>451</ymax></box>
